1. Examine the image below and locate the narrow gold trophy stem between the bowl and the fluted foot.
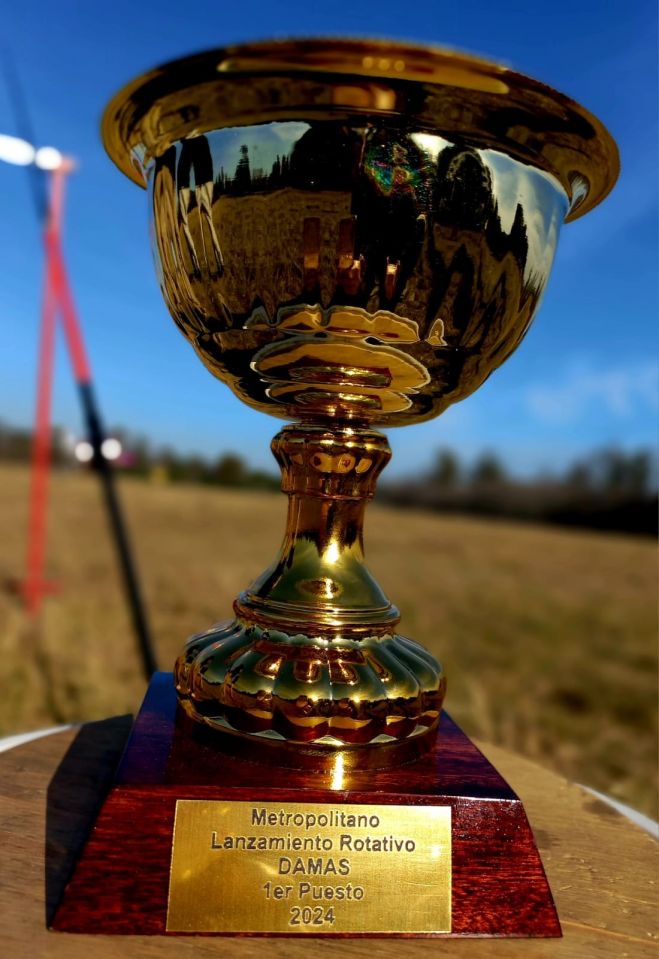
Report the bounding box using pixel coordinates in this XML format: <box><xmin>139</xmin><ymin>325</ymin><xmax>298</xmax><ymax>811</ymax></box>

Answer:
<box><xmin>235</xmin><ymin>425</ymin><xmax>400</xmax><ymax>638</ymax></box>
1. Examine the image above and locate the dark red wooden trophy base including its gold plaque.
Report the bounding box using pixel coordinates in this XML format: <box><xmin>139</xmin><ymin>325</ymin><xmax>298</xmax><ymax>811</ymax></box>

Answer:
<box><xmin>52</xmin><ymin>673</ymin><xmax>561</xmax><ymax>937</ymax></box>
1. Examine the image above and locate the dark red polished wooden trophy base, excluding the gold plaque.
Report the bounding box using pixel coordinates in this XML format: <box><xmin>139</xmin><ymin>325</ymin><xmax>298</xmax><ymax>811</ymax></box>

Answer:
<box><xmin>52</xmin><ymin>673</ymin><xmax>561</xmax><ymax>937</ymax></box>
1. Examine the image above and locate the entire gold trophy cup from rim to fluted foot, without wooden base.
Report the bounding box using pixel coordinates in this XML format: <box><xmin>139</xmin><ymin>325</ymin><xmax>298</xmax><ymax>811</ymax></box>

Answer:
<box><xmin>103</xmin><ymin>40</ymin><xmax>618</xmax><ymax>767</ymax></box>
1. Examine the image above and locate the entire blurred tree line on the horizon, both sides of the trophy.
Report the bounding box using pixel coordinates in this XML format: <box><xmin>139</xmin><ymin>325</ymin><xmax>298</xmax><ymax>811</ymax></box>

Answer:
<box><xmin>0</xmin><ymin>423</ymin><xmax>658</xmax><ymax>536</ymax></box>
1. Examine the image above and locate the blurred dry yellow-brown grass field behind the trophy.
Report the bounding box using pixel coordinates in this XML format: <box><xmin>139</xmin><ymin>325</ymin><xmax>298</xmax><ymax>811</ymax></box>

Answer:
<box><xmin>0</xmin><ymin>466</ymin><xmax>657</xmax><ymax>815</ymax></box>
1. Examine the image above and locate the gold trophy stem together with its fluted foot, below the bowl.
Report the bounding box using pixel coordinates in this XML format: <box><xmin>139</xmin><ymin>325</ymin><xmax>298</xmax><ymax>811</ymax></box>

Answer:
<box><xmin>175</xmin><ymin>424</ymin><xmax>446</xmax><ymax>768</ymax></box>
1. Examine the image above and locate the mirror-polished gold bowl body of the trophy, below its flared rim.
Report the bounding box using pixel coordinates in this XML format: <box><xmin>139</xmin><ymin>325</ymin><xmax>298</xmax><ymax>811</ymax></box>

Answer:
<box><xmin>150</xmin><ymin>120</ymin><xmax>568</xmax><ymax>425</ymax></box>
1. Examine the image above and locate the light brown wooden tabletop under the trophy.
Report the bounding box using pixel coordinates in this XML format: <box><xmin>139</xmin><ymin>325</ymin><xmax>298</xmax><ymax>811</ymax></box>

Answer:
<box><xmin>0</xmin><ymin>717</ymin><xmax>659</xmax><ymax>959</ymax></box>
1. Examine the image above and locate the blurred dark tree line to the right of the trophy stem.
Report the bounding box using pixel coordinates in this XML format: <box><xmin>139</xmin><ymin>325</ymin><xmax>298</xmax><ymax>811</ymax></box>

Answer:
<box><xmin>380</xmin><ymin>448</ymin><xmax>658</xmax><ymax>536</ymax></box>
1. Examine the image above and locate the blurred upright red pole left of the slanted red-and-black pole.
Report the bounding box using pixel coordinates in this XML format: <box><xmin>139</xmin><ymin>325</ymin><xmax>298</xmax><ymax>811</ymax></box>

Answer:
<box><xmin>24</xmin><ymin>169</ymin><xmax>65</xmax><ymax>616</ymax></box>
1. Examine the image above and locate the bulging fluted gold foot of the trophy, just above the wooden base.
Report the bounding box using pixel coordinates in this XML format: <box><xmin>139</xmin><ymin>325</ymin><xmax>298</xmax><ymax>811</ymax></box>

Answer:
<box><xmin>175</xmin><ymin>620</ymin><xmax>446</xmax><ymax>747</ymax></box>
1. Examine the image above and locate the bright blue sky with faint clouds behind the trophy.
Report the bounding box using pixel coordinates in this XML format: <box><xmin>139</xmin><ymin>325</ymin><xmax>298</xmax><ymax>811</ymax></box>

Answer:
<box><xmin>0</xmin><ymin>0</ymin><xmax>659</xmax><ymax>477</ymax></box>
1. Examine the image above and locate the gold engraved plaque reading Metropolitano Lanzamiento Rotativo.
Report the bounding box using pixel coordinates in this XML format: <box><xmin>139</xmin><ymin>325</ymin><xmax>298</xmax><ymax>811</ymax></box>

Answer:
<box><xmin>167</xmin><ymin>799</ymin><xmax>451</xmax><ymax>935</ymax></box>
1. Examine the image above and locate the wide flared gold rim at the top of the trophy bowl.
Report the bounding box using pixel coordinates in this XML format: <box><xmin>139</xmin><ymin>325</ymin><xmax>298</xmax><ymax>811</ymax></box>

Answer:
<box><xmin>102</xmin><ymin>37</ymin><xmax>620</xmax><ymax>222</ymax></box>
